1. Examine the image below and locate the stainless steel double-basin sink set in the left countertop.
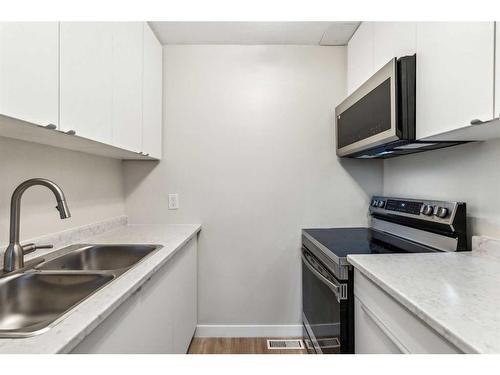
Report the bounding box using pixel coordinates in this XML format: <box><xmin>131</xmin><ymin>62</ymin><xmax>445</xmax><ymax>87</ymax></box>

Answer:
<box><xmin>0</xmin><ymin>245</ymin><xmax>161</xmax><ymax>338</ymax></box>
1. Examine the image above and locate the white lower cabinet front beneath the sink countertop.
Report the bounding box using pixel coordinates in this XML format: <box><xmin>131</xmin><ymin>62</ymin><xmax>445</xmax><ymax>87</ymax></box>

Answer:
<box><xmin>72</xmin><ymin>239</ymin><xmax>197</xmax><ymax>354</ymax></box>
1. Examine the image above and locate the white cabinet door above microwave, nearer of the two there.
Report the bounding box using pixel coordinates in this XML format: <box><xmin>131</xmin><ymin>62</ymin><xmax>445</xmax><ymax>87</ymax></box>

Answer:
<box><xmin>373</xmin><ymin>22</ymin><xmax>417</xmax><ymax>73</ymax></box>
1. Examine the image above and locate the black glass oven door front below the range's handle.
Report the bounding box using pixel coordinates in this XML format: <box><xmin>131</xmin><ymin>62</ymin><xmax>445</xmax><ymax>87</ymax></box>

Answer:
<box><xmin>302</xmin><ymin>253</ymin><xmax>342</xmax><ymax>354</ymax></box>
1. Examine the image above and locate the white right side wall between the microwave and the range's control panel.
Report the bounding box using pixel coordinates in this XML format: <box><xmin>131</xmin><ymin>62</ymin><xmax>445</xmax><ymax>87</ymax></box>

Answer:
<box><xmin>384</xmin><ymin>140</ymin><xmax>500</xmax><ymax>237</ymax></box>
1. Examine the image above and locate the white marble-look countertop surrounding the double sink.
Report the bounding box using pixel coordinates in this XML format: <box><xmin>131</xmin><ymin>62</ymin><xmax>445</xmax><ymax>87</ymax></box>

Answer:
<box><xmin>0</xmin><ymin>224</ymin><xmax>201</xmax><ymax>354</ymax></box>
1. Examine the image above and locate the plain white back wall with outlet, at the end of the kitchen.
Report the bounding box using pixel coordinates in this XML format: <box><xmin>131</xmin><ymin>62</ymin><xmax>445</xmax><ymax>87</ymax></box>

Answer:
<box><xmin>124</xmin><ymin>46</ymin><xmax>382</xmax><ymax>325</ymax></box>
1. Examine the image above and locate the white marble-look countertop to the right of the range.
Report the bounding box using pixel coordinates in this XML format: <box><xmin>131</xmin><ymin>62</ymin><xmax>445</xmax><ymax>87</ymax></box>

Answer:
<box><xmin>347</xmin><ymin>237</ymin><xmax>500</xmax><ymax>353</ymax></box>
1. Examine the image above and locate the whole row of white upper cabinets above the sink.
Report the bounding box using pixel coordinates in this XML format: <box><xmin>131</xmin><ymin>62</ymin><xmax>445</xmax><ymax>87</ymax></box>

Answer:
<box><xmin>0</xmin><ymin>22</ymin><xmax>163</xmax><ymax>159</ymax></box>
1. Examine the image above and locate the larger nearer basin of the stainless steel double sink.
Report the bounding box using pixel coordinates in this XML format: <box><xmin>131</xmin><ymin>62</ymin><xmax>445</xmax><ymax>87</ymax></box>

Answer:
<box><xmin>0</xmin><ymin>271</ymin><xmax>114</xmax><ymax>337</ymax></box>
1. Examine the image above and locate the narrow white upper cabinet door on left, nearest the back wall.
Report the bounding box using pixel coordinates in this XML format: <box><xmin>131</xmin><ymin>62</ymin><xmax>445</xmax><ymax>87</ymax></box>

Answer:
<box><xmin>142</xmin><ymin>23</ymin><xmax>163</xmax><ymax>159</ymax></box>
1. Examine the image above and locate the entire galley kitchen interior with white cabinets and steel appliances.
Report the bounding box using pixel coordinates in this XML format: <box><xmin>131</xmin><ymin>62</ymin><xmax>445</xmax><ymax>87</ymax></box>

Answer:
<box><xmin>0</xmin><ymin>6</ymin><xmax>500</xmax><ymax>370</ymax></box>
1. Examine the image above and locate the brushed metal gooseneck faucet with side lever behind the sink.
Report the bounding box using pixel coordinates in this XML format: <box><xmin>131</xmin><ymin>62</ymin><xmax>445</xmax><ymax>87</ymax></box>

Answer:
<box><xmin>3</xmin><ymin>178</ymin><xmax>71</xmax><ymax>273</ymax></box>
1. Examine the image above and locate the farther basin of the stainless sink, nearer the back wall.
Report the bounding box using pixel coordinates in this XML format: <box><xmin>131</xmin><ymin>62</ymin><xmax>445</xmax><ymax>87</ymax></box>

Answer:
<box><xmin>37</xmin><ymin>245</ymin><xmax>158</xmax><ymax>271</ymax></box>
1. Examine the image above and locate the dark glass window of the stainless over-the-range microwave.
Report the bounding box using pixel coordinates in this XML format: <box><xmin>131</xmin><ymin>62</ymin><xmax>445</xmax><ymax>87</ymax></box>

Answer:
<box><xmin>337</xmin><ymin>78</ymin><xmax>391</xmax><ymax>148</ymax></box>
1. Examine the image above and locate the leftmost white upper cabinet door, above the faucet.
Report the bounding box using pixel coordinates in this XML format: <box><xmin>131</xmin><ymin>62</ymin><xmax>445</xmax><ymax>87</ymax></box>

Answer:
<box><xmin>0</xmin><ymin>22</ymin><xmax>59</xmax><ymax>125</ymax></box>
